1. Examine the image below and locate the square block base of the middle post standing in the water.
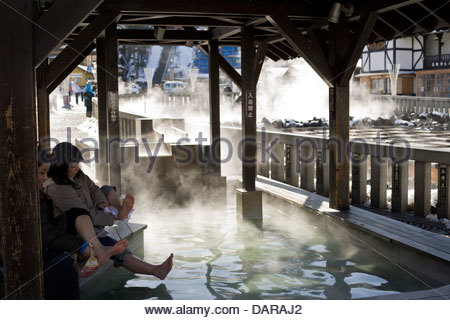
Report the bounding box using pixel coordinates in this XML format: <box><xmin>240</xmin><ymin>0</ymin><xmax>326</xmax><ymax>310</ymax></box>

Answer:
<box><xmin>236</xmin><ymin>189</ymin><xmax>263</xmax><ymax>220</ymax></box>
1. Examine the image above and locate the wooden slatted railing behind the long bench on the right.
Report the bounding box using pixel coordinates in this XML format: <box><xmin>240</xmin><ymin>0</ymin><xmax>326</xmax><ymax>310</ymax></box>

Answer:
<box><xmin>221</xmin><ymin>127</ymin><xmax>450</xmax><ymax>219</ymax></box>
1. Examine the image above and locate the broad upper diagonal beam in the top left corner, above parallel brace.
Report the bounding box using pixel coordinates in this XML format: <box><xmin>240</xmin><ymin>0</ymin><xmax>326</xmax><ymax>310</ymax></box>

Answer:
<box><xmin>34</xmin><ymin>0</ymin><xmax>103</xmax><ymax>66</ymax></box>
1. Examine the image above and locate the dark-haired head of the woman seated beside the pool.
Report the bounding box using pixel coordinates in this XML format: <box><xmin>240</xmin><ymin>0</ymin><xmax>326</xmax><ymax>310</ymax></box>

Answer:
<box><xmin>48</xmin><ymin>142</ymin><xmax>83</xmax><ymax>184</ymax></box>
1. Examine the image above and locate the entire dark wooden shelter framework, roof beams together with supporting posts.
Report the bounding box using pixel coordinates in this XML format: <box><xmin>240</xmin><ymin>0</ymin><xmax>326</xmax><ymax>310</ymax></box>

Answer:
<box><xmin>0</xmin><ymin>0</ymin><xmax>450</xmax><ymax>299</ymax></box>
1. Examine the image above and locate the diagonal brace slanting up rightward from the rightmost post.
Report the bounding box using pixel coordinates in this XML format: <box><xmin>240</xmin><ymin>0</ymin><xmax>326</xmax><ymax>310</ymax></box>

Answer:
<box><xmin>338</xmin><ymin>12</ymin><xmax>378</xmax><ymax>86</ymax></box>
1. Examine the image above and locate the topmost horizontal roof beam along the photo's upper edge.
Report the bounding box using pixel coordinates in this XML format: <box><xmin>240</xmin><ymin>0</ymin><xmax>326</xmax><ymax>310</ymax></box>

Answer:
<box><xmin>100</xmin><ymin>0</ymin><xmax>315</xmax><ymax>18</ymax></box>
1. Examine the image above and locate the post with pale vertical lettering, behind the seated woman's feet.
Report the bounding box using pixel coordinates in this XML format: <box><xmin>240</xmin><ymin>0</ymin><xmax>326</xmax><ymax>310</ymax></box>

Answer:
<box><xmin>105</xmin><ymin>23</ymin><xmax>121</xmax><ymax>195</ymax></box>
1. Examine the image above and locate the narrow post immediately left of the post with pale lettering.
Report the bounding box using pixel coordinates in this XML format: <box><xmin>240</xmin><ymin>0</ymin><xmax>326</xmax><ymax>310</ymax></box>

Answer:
<box><xmin>95</xmin><ymin>37</ymin><xmax>109</xmax><ymax>184</ymax></box>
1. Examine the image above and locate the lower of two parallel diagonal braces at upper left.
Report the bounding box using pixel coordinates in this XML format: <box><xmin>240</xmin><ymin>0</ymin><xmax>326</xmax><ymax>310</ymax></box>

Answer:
<box><xmin>46</xmin><ymin>12</ymin><xmax>120</xmax><ymax>87</ymax></box>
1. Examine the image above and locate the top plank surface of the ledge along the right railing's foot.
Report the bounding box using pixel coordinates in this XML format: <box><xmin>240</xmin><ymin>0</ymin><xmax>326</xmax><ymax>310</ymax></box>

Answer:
<box><xmin>256</xmin><ymin>176</ymin><xmax>450</xmax><ymax>265</ymax></box>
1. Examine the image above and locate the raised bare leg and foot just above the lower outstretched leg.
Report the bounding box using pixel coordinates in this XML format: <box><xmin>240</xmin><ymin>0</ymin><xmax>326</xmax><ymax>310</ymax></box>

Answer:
<box><xmin>75</xmin><ymin>215</ymin><xmax>128</xmax><ymax>265</ymax></box>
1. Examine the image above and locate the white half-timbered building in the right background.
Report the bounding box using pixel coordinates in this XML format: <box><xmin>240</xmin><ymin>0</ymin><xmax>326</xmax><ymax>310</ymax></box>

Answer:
<box><xmin>356</xmin><ymin>31</ymin><xmax>450</xmax><ymax>97</ymax></box>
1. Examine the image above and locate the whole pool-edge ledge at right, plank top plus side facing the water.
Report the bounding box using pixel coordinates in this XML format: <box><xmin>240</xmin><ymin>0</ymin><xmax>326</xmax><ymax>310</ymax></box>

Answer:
<box><xmin>256</xmin><ymin>176</ymin><xmax>450</xmax><ymax>284</ymax></box>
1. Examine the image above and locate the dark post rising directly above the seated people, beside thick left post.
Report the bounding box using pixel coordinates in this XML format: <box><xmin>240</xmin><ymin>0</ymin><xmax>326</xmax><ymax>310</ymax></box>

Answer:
<box><xmin>36</xmin><ymin>60</ymin><xmax>50</xmax><ymax>149</ymax></box>
